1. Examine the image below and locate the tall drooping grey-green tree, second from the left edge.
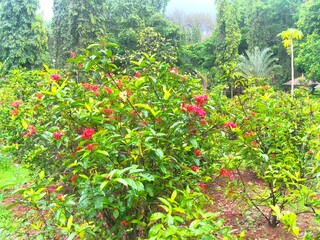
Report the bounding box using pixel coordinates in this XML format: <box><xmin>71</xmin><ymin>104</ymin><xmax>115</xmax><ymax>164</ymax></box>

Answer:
<box><xmin>52</xmin><ymin>0</ymin><xmax>107</xmax><ymax>67</ymax></box>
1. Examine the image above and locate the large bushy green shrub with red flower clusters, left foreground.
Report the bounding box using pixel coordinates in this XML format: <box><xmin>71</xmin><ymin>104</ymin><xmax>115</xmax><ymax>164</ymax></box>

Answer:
<box><xmin>1</xmin><ymin>39</ymin><xmax>235</xmax><ymax>239</ymax></box>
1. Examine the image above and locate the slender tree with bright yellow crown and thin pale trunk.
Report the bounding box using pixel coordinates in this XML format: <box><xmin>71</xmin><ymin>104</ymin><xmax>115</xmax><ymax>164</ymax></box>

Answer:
<box><xmin>278</xmin><ymin>28</ymin><xmax>302</xmax><ymax>97</ymax></box>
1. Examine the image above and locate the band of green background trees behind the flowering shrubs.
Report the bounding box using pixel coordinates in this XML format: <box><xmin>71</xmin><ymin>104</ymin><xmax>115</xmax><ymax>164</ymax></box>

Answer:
<box><xmin>0</xmin><ymin>0</ymin><xmax>320</xmax><ymax>84</ymax></box>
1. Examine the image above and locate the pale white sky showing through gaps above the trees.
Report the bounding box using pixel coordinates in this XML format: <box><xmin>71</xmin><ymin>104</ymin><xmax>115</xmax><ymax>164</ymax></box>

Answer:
<box><xmin>39</xmin><ymin>0</ymin><xmax>214</xmax><ymax>21</ymax></box>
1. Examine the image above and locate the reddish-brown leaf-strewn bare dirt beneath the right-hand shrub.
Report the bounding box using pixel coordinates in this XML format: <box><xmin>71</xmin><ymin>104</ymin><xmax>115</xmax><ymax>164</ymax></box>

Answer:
<box><xmin>208</xmin><ymin>171</ymin><xmax>314</xmax><ymax>240</ymax></box>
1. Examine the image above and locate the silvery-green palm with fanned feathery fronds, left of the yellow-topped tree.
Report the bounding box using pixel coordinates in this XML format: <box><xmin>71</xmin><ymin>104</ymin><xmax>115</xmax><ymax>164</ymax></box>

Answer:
<box><xmin>237</xmin><ymin>47</ymin><xmax>280</xmax><ymax>82</ymax></box>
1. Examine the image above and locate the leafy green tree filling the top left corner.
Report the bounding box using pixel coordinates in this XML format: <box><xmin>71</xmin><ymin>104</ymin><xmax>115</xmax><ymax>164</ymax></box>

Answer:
<box><xmin>0</xmin><ymin>0</ymin><xmax>48</xmax><ymax>69</ymax></box>
